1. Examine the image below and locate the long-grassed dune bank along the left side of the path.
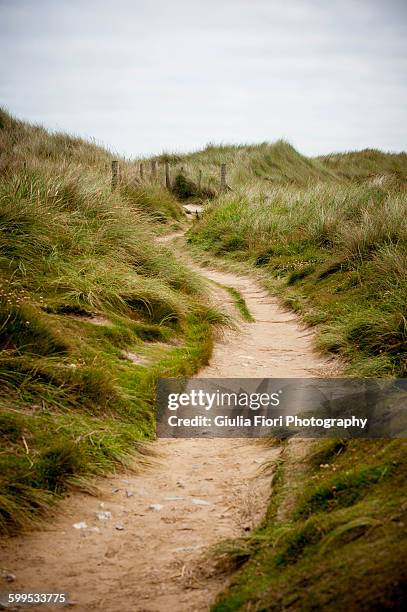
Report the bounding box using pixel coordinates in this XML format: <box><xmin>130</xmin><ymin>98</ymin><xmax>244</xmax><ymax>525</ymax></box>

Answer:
<box><xmin>0</xmin><ymin>112</ymin><xmax>223</xmax><ymax>533</ymax></box>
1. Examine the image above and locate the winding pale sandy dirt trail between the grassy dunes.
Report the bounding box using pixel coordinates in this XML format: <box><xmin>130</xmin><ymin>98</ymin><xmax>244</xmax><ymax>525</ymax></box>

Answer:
<box><xmin>0</xmin><ymin>237</ymin><xmax>327</xmax><ymax>612</ymax></box>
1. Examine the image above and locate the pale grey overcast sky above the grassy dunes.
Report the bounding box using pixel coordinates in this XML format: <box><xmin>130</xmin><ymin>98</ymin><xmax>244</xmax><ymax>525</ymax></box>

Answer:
<box><xmin>0</xmin><ymin>0</ymin><xmax>407</xmax><ymax>157</ymax></box>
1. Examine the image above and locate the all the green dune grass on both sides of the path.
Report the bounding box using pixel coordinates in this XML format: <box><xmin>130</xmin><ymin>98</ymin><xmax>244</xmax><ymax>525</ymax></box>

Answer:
<box><xmin>0</xmin><ymin>112</ymin><xmax>407</xmax><ymax>612</ymax></box>
